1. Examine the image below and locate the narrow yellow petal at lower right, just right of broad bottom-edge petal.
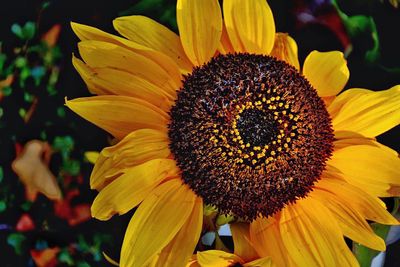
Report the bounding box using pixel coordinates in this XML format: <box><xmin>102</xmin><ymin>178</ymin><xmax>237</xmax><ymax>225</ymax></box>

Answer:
<box><xmin>310</xmin><ymin>187</ymin><xmax>386</xmax><ymax>251</ymax></box>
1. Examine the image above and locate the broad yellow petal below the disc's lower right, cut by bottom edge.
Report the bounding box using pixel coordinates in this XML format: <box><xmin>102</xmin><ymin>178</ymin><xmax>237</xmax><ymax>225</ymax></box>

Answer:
<box><xmin>280</xmin><ymin>198</ymin><xmax>358</xmax><ymax>266</ymax></box>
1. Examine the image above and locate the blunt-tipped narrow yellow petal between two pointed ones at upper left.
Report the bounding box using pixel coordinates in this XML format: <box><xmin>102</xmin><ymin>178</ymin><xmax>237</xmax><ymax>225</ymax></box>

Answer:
<box><xmin>78</xmin><ymin>41</ymin><xmax>182</xmax><ymax>96</ymax></box>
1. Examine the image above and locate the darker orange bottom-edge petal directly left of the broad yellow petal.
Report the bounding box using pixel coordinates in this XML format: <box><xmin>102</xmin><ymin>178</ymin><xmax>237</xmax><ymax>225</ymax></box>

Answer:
<box><xmin>250</xmin><ymin>214</ymin><xmax>293</xmax><ymax>266</ymax></box>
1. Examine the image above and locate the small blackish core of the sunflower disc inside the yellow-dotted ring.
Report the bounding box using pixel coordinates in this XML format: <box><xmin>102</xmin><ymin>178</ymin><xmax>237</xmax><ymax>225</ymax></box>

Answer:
<box><xmin>236</xmin><ymin>109</ymin><xmax>278</xmax><ymax>146</ymax></box>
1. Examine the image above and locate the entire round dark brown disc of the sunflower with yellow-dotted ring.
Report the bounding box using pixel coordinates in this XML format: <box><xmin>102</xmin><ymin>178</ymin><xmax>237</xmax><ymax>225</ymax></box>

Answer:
<box><xmin>168</xmin><ymin>53</ymin><xmax>333</xmax><ymax>221</ymax></box>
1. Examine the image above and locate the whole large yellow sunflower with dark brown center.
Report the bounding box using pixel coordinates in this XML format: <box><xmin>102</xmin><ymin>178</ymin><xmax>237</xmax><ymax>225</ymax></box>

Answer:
<box><xmin>66</xmin><ymin>0</ymin><xmax>400</xmax><ymax>266</ymax></box>
